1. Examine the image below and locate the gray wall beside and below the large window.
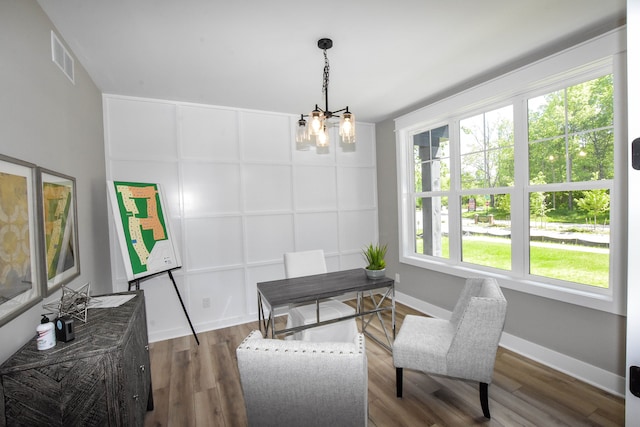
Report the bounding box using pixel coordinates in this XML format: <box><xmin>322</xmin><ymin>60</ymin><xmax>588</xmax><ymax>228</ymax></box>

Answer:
<box><xmin>376</xmin><ymin>113</ymin><xmax>626</xmax><ymax>376</ymax></box>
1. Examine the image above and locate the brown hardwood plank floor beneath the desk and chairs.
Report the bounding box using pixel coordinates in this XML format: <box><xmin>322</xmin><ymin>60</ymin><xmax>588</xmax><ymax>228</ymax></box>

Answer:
<box><xmin>145</xmin><ymin>304</ymin><xmax>624</xmax><ymax>427</ymax></box>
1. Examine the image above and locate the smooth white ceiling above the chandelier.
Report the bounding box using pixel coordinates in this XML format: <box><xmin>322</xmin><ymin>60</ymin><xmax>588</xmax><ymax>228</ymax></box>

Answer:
<box><xmin>38</xmin><ymin>0</ymin><xmax>626</xmax><ymax>122</ymax></box>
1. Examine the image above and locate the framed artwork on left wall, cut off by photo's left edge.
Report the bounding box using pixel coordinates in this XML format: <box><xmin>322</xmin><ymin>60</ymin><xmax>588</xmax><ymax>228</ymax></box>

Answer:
<box><xmin>0</xmin><ymin>155</ymin><xmax>42</xmax><ymax>326</ymax></box>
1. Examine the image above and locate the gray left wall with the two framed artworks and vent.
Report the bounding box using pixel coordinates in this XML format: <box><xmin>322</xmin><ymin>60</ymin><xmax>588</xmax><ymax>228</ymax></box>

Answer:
<box><xmin>0</xmin><ymin>0</ymin><xmax>111</xmax><ymax>362</ymax></box>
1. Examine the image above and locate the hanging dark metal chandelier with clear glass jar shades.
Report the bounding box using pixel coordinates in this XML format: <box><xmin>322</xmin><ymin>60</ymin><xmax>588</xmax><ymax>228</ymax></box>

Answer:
<box><xmin>296</xmin><ymin>39</ymin><xmax>356</xmax><ymax>154</ymax></box>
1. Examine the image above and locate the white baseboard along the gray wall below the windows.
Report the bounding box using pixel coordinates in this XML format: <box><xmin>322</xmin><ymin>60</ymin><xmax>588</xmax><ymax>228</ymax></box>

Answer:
<box><xmin>396</xmin><ymin>290</ymin><xmax>625</xmax><ymax>397</ymax></box>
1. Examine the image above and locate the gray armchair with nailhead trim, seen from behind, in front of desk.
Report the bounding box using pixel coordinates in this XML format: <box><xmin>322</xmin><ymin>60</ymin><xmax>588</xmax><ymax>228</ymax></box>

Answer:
<box><xmin>236</xmin><ymin>331</ymin><xmax>368</xmax><ymax>427</ymax></box>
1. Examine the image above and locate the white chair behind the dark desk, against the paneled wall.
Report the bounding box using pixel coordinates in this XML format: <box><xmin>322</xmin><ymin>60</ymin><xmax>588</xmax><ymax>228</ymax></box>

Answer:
<box><xmin>284</xmin><ymin>249</ymin><xmax>358</xmax><ymax>342</ymax></box>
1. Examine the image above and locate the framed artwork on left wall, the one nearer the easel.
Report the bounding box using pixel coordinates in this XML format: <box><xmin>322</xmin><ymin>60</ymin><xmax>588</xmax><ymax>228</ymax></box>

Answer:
<box><xmin>38</xmin><ymin>168</ymin><xmax>80</xmax><ymax>296</ymax></box>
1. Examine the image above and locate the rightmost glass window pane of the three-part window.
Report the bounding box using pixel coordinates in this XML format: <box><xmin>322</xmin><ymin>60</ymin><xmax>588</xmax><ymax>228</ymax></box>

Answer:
<box><xmin>527</xmin><ymin>74</ymin><xmax>614</xmax><ymax>288</ymax></box>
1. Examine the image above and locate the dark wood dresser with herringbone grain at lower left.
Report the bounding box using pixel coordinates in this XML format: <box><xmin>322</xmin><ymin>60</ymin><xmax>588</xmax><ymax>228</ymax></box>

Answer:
<box><xmin>0</xmin><ymin>291</ymin><xmax>153</xmax><ymax>427</ymax></box>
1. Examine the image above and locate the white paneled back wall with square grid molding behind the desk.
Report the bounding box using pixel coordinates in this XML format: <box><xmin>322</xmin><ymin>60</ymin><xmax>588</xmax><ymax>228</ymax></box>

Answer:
<box><xmin>104</xmin><ymin>95</ymin><xmax>378</xmax><ymax>341</ymax></box>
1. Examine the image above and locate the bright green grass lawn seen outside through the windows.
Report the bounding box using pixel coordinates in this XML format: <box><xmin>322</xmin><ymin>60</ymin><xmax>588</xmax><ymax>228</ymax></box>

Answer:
<box><xmin>416</xmin><ymin>237</ymin><xmax>609</xmax><ymax>288</ymax></box>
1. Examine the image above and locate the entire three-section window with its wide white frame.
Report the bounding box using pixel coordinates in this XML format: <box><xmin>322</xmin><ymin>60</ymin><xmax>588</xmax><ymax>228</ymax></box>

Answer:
<box><xmin>396</xmin><ymin>28</ymin><xmax>626</xmax><ymax>312</ymax></box>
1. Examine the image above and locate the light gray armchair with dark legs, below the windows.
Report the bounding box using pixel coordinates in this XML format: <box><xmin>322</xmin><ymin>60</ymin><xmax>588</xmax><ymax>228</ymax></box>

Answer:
<box><xmin>393</xmin><ymin>278</ymin><xmax>507</xmax><ymax>418</ymax></box>
